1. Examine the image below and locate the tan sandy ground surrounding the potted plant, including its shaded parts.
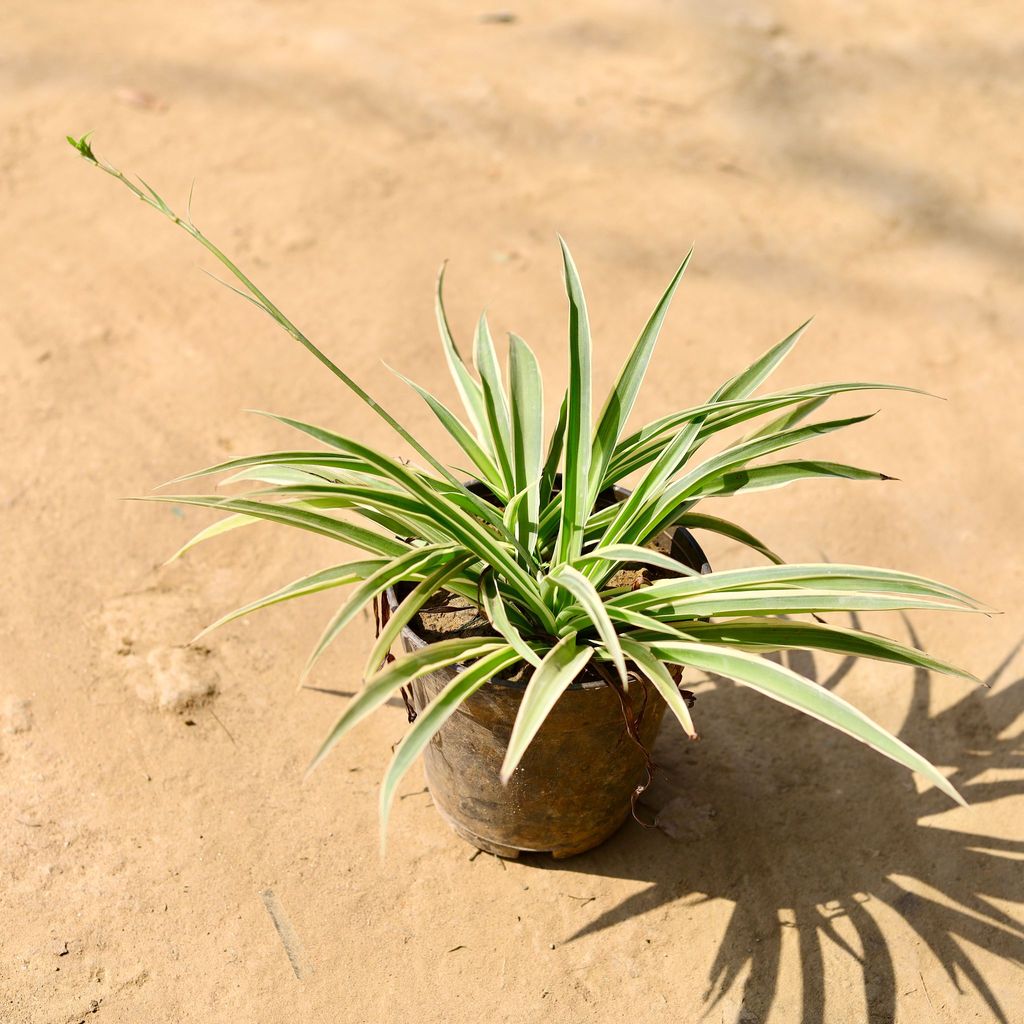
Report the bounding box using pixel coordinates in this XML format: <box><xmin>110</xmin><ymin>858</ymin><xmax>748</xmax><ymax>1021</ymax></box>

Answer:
<box><xmin>0</xmin><ymin>0</ymin><xmax>1024</xmax><ymax>1024</ymax></box>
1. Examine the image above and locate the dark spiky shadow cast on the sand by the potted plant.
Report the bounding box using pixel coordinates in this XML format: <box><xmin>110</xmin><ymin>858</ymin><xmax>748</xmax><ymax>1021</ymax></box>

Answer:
<box><xmin>523</xmin><ymin>620</ymin><xmax>1024</xmax><ymax>1024</ymax></box>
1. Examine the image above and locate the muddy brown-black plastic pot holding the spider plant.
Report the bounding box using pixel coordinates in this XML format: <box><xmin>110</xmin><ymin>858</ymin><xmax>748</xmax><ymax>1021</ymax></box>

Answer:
<box><xmin>387</xmin><ymin>488</ymin><xmax>710</xmax><ymax>858</ymax></box>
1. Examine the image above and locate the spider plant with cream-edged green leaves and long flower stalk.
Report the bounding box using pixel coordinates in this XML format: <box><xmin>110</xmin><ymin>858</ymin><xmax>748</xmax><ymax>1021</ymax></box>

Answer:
<box><xmin>69</xmin><ymin>137</ymin><xmax>980</xmax><ymax>833</ymax></box>
